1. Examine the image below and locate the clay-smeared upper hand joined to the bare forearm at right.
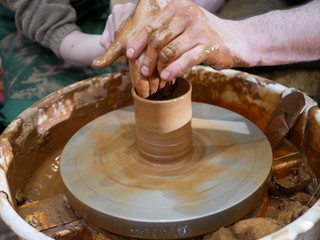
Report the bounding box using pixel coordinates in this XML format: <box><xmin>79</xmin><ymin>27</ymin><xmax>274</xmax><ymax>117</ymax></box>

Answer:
<box><xmin>126</xmin><ymin>0</ymin><xmax>247</xmax><ymax>80</ymax></box>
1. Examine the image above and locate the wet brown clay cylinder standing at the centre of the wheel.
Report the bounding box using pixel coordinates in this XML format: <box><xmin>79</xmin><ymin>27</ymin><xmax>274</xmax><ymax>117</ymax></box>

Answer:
<box><xmin>132</xmin><ymin>78</ymin><xmax>192</xmax><ymax>164</ymax></box>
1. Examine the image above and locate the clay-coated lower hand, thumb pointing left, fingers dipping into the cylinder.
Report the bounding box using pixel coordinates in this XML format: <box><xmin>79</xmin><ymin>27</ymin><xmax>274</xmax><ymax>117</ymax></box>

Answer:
<box><xmin>92</xmin><ymin>0</ymin><xmax>172</xmax><ymax>98</ymax></box>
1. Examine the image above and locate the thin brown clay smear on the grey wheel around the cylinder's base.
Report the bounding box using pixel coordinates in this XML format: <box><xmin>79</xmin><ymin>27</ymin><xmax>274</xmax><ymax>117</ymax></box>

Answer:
<box><xmin>92</xmin><ymin>121</ymin><xmax>225</xmax><ymax>202</ymax></box>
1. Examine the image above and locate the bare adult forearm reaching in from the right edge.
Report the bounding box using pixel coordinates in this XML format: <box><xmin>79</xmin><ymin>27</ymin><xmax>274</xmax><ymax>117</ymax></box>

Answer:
<box><xmin>237</xmin><ymin>0</ymin><xmax>320</xmax><ymax>66</ymax></box>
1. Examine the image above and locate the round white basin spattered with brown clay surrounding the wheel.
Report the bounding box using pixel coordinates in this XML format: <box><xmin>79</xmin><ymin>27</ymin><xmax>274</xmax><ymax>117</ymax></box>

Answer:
<box><xmin>0</xmin><ymin>66</ymin><xmax>320</xmax><ymax>240</ymax></box>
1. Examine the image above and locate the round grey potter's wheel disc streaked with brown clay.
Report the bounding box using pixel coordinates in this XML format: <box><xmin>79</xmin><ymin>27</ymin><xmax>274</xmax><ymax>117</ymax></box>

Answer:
<box><xmin>60</xmin><ymin>103</ymin><xmax>272</xmax><ymax>239</ymax></box>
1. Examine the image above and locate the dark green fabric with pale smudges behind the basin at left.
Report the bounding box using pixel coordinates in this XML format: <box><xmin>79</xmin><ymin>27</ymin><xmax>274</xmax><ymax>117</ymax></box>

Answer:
<box><xmin>0</xmin><ymin>0</ymin><xmax>117</xmax><ymax>125</ymax></box>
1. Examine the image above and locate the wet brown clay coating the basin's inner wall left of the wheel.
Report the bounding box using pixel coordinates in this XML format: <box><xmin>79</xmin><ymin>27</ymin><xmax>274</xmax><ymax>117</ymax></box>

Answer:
<box><xmin>8</xmin><ymin>73</ymin><xmax>133</xmax><ymax>205</ymax></box>
